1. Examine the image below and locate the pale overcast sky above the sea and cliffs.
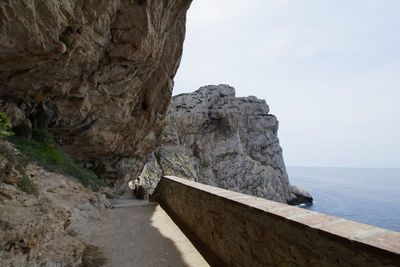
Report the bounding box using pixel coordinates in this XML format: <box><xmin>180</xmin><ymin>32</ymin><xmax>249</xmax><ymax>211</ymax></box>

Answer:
<box><xmin>174</xmin><ymin>0</ymin><xmax>400</xmax><ymax>167</ymax></box>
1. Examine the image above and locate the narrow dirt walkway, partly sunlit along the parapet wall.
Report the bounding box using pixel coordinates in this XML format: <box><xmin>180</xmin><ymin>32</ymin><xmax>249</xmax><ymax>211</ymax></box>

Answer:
<box><xmin>89</xmin><ymin>190</ymin><xmax>209</xmax><ymax>267</ymax></box>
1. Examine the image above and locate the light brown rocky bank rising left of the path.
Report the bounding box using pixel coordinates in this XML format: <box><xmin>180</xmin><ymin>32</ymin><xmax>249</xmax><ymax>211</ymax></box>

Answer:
<box><xmin>0</xmin><ymin>141</ymin><xmax>110</xmax><ymax>266</ymax></box>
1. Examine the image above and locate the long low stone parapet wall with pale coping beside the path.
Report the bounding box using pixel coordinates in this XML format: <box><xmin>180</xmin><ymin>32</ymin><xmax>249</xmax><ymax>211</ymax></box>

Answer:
<box><xmin>153</xmin><ymin>176</ymin><xmax>400</xmax><ymax>266</ymax></box>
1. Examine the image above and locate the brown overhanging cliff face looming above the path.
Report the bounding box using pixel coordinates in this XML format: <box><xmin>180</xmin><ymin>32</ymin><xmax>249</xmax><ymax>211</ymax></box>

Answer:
<box><xmin>0</xmin><ymin>0</ymin><xmax>191</xmax><ymax>192</ymax></box>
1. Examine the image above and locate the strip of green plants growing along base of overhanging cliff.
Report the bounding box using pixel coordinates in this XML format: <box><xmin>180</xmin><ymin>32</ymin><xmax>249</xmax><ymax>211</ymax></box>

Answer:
<box><xmin>10</xmin><ymin>130</ymin><xmax>104</xmax><ymax>190</ymax></box>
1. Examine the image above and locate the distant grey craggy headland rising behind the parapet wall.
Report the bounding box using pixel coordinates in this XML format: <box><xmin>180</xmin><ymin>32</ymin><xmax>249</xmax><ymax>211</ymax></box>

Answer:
<box><xmin>140</xmin><ymin>85</ymin><xmax>312</xmax><ymax>204</ymax></box>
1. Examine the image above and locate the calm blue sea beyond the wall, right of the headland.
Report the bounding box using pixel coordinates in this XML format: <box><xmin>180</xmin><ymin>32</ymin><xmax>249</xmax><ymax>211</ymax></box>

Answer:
<box><xmin>287</xmin><ymin>167</ymin><xmax>400</xmax><ymax>232</ymax></box>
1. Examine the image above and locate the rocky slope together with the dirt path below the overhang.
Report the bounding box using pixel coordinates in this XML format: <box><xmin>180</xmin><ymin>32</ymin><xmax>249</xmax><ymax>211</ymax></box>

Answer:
<box><xmin>0</xmin><ymin>141</ymin><xmax>208</xmax><ymax>267</ymax></box>
